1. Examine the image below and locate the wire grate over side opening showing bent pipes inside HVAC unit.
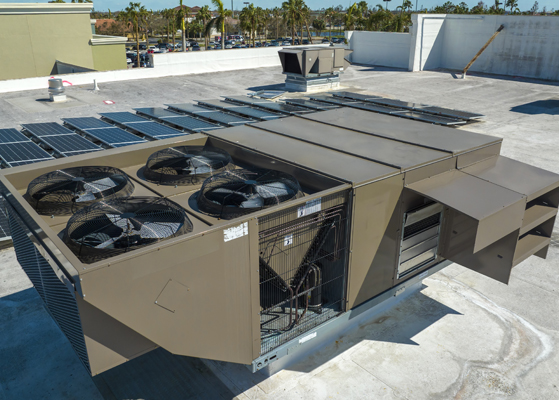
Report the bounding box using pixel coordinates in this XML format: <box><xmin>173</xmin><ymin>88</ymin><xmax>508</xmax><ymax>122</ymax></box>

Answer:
<box><xmin>258</xmin><ymin>191</ymin><xmax>349</xmax><ymax>354</ymax></box>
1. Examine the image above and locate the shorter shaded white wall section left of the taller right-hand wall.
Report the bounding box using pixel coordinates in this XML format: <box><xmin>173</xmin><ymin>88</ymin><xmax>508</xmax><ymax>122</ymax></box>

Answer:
<box><xmin>346</xmin><ymin>31</ymin><xmax>411</xmax><ymax>69</ymax></box>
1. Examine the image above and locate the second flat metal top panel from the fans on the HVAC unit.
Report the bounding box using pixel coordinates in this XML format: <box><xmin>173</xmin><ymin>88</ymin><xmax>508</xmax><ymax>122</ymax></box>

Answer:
<box><xmin>252</xmin><ymin>117</ymin><xmax>450</xmax><ymax>171</ymax></box>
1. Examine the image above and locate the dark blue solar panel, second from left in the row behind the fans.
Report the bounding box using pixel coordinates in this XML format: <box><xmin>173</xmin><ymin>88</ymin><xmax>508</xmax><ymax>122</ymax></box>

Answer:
<box><xmin>22</xmin><ymin>122</ymin><xmax>102</xmax><ymax>157</ymax></box>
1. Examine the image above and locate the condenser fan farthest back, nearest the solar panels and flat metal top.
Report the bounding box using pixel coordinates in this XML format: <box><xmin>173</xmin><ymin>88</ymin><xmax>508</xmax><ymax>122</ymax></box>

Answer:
<box><xmin>144</xmin><ymin>146</ymin><xmax>233</xmax><ymax>185</ymax></box>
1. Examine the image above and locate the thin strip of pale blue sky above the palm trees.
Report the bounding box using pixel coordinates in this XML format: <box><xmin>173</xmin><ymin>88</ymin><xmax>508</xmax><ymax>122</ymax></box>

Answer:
<box><xmin>15</xmin><ymin>0</ymin><xmax>559</xmax><ymax>11</ymax></box>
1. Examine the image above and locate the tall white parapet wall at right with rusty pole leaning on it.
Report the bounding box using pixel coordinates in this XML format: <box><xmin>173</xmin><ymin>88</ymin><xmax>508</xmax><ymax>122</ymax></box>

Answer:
<box><xmin>409</xmin><ymin>14</ymin><xmax>559</xmax><ymax>80</ymax></box>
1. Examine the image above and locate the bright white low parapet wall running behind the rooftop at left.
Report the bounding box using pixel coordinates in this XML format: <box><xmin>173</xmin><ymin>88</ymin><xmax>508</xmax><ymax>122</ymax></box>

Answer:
<box><xmin>0</xmin><ymin>46</ymin><xmax>328</xmax><ymax>93</ymax></box>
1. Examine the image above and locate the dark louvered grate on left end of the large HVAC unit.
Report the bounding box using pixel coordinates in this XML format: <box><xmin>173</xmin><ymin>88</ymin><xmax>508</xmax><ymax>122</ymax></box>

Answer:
<box><xmin>8</xmin><ymin>213</ymin><xmax>91</xmax><ymax>373</ymax></box>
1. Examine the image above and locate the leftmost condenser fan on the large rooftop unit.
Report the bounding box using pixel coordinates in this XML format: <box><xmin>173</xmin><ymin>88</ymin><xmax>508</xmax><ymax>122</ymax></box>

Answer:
<box><xmin>25</xmin><ymin>166</ymin><xmax>134</xmax><ymax>215</ymax></box>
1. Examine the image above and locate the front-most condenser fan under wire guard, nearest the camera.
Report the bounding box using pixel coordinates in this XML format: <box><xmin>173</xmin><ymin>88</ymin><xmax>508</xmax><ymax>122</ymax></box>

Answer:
<box><xmin>63</xmin><ymin>197</ymin><xmax>192</xmax><ymax>264</ymax></box>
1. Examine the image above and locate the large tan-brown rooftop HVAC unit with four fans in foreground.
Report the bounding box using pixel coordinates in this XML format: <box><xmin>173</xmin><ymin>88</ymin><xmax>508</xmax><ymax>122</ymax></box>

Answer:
<box><xmin>0</xmin><ymin>109</ymin><xmax>559</xmax><ymax>375</ymax></box>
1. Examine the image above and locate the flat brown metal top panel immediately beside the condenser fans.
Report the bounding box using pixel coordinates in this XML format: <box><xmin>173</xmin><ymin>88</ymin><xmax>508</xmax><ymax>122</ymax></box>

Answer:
<box><xmin>209</xmin><ymin>126</ymin><xmax>400</xmax><ymax>185</ymax></box>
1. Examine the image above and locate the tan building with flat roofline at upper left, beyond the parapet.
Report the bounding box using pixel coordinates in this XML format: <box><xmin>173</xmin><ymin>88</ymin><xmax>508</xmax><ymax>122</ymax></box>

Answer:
<box><xmin>0</xmin><ymin>3</ymin><xmax>126</xmax><ymax>80</ymax></box>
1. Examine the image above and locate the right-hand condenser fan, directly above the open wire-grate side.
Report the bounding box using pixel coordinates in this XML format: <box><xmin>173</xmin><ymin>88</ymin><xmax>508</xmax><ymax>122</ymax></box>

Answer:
<box><xmin>197</xmin><ymin>169</ymin><xmax>303</xmax><ymax>219</ymax></box>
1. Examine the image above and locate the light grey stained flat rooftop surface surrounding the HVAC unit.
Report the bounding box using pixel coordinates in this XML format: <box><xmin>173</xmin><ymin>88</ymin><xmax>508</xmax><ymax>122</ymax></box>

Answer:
<box><xmin>0</xmin><ymin>65</ymin><xmax>559</xmax><ymax>399</ymax></box>
